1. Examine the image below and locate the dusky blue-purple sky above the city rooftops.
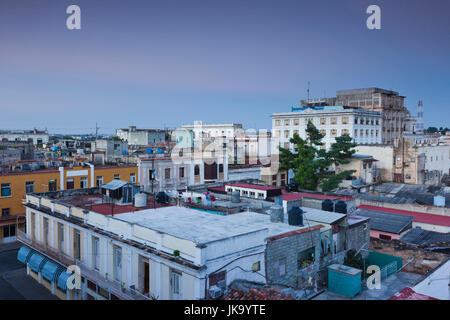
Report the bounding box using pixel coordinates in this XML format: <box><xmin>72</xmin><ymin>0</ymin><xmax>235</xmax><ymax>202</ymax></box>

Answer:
<box><xmin>0</xmin><ymin>0</ymin><xmax>450</xmax><ymax>134</ymax></box>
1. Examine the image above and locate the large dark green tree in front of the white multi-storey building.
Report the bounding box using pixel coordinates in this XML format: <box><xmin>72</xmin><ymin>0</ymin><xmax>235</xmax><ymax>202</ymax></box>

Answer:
<box><xmin>279</xmin><ymin>121</ymin><xmax>356</xmax><ymax>191</ymax></box>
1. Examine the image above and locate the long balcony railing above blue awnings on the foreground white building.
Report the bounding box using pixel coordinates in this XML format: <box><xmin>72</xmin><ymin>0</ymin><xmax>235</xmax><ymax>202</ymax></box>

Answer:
<box><xmin>17</xmin><ymin>230</ymin><xmax>151</xmax><ymax>300</ymax></box>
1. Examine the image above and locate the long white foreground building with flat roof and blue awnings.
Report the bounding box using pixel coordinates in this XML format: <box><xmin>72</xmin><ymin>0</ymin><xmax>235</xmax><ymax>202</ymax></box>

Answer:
<box><xmin>19</xmin><ymin>189</ymin><xmax>321</xmax><ymax>300</ymax></box>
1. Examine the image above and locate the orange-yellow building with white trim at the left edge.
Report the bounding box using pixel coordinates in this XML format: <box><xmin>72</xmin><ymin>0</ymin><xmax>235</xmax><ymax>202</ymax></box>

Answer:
<box><xmin>0</xmin><ymin>164</ymin><xmax>138</xmax><ymax>243</ymax></box>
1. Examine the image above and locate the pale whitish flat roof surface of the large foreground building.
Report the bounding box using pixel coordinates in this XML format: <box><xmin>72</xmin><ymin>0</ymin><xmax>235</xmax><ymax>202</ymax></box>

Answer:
<box><xmin>115</xmin><ymin>207</ymin><xmax>320</xmax><ymax>244</ymax></box>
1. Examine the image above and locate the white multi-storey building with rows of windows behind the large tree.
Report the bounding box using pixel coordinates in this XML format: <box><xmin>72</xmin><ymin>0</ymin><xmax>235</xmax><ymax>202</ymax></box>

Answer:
<box><xmin>271</xmin><ymin>106</ymin><xmax>382</xmax><ymax>149</ymax></box>
